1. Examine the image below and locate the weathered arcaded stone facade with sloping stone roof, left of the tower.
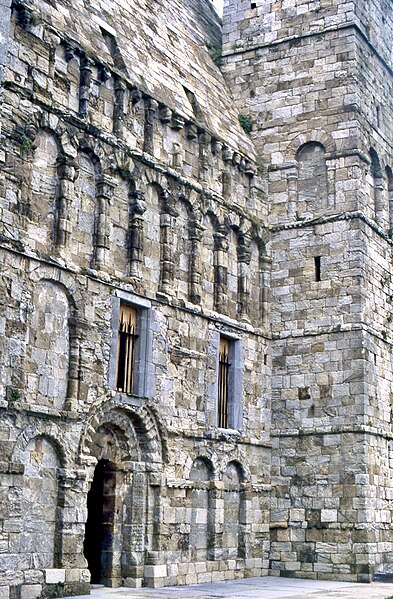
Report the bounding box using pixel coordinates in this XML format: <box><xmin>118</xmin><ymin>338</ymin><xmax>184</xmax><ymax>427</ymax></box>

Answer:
<box><xmin>0</xmin><ymin>1</ymin><xmax>271</xmax><ymax>599</ymax></box>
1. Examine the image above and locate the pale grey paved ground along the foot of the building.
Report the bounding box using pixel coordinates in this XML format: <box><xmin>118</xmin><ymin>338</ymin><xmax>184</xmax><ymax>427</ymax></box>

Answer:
<box><xmin>64</xmin><ymin>576</ymin><xmax>393</xmax><ymax>599</ymax></box>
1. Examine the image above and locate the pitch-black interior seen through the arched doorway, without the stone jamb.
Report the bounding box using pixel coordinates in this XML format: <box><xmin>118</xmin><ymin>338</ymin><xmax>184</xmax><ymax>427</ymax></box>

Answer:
<box><xmin>83</xmin><ymin>460</ymin><xmax>109</xmax><ymax>584</ymax></box>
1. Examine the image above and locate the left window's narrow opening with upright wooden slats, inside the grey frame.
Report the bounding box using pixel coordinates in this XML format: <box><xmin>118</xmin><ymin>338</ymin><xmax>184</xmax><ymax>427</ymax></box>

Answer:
<box><xmin>116</xmin><ymin>304</ymin><xmax>138</xmax><ymax>394</ymax></box>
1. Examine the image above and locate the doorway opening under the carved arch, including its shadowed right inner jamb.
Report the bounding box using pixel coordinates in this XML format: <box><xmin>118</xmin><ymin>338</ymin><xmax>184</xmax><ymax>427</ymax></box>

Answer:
<box><xmin>83</xmin><ymin>459</ymin><xmax>116</xmax><ymax>586</ymax></box>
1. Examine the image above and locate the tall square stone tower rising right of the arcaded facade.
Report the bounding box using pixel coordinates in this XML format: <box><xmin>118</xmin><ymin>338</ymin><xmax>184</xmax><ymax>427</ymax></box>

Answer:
<box><xmin>223</xmin><ymin>0</ymin><xmax>393</xmax><ymax>581</ymax></box>
